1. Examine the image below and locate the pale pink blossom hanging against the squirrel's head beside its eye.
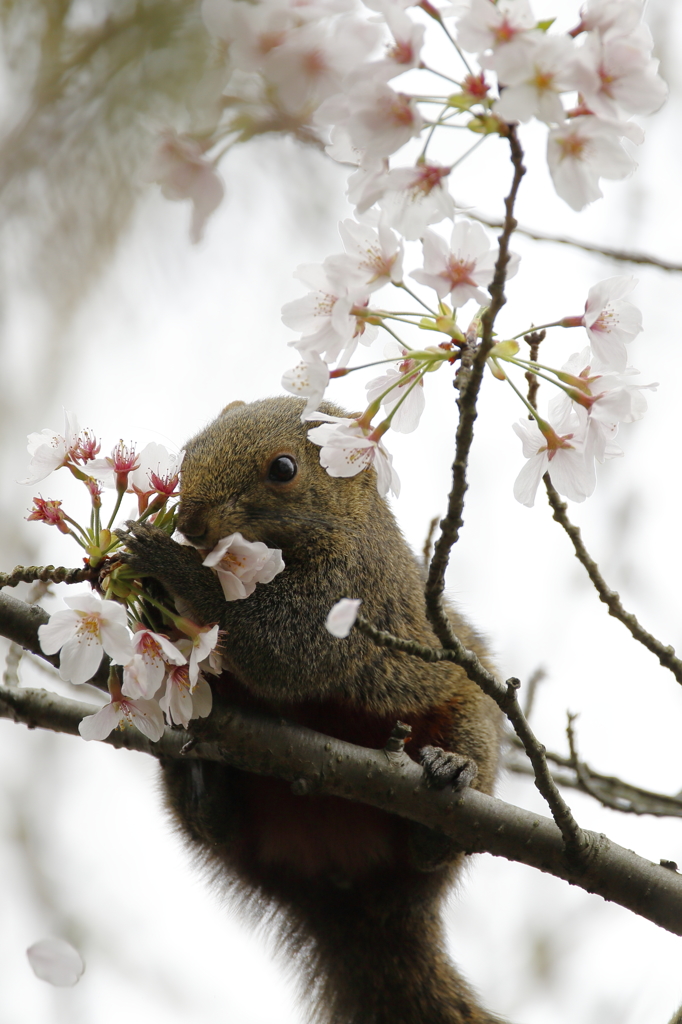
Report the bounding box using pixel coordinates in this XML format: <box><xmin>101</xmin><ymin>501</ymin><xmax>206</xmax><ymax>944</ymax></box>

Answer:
<box><xmin>307</xmin><ymin>412</ymin><xmax>400</xmax><ymax>497</ymax></box>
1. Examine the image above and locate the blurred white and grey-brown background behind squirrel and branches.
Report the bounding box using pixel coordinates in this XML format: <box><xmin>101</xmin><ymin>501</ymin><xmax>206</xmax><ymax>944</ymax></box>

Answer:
<box><xmin>0</xmin><ymin>0</ymin><xmax>682</xmax><ymax>1024</ymax></box>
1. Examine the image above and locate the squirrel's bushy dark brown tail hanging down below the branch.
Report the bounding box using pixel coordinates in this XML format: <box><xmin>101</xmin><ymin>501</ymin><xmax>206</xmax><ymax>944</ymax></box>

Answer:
<box><xmin>262</xmin><ymin>872</ymin><xmax>501</xmax><ymax>1024</ymax></box>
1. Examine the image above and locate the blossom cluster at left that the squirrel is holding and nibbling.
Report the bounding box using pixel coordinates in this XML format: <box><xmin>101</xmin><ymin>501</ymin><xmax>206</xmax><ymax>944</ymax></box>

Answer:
<box><xmin>20</xmin><ymin>413</ymin><xmax>284</xmax><ymax>741</ymax></box>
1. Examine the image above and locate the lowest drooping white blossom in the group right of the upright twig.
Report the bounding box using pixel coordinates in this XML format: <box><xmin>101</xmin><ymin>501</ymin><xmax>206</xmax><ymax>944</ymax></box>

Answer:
<box><xmin>513</xmin><ymin>418</ymin><xmax>597</xmax><ymax>508</ymax></box>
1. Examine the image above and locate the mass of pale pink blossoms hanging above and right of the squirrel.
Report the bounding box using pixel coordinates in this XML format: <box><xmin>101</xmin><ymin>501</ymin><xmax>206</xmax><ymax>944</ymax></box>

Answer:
<box><xmin>148</xmin><ymin>0</ymin><xmax>667</xmax><ymax>505</ymax></box>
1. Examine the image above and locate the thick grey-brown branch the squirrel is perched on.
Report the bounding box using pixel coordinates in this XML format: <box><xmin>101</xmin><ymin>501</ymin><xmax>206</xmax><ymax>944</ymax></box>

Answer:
<box><xmin>0</xmin><ymin>689</ymin><xmax>682</xmax><ymax>935</ymax></box>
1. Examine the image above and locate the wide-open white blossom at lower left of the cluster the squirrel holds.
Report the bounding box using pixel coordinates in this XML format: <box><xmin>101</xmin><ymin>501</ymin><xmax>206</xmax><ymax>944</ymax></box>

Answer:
<box><xmin>38</xmin><ymin>594</ymin><xmax>133</xmax><ymax>684</ymax></box>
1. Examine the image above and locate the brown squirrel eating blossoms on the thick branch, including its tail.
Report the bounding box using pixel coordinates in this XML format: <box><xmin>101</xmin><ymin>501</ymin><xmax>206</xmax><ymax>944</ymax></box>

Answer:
<box><xmin>123</xmin><ymin>397</ymin><xmax>502</xmax><ymax>1024</ymax></box>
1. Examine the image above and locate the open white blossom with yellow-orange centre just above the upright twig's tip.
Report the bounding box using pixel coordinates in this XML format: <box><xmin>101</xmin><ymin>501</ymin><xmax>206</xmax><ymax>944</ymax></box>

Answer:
<box><xmin>493</xmin><ymin>36</ymin><xmax>599</xmax><ymax>124</ymax></box>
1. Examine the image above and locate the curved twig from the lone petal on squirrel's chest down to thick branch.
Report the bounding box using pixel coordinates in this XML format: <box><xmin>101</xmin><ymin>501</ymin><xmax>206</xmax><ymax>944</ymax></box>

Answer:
<box><xmin>355</xmin><ymin>615</ymin><xmax>586</xmax><ymax>855</ymax></box>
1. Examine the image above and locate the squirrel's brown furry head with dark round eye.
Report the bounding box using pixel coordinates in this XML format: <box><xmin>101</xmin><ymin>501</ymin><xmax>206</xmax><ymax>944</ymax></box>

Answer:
<box><xmin>177</xmin><ymin>397</ymin><xmax>390</xmax><ymax>558</ymax></box>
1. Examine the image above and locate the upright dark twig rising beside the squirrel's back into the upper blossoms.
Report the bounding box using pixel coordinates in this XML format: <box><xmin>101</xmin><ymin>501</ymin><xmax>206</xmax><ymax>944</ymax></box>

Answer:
<box><xmin>425</xmin><ymin>126</ymin><xmax>525</xmax><ymax>646</ymax></box>
